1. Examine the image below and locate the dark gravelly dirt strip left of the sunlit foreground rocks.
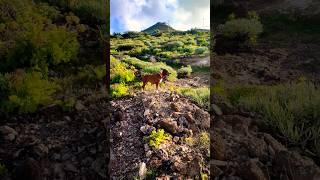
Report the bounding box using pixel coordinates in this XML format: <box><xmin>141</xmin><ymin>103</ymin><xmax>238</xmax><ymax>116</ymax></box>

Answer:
<box><xmin>110</xmin><ymin>98</ymin><xmax>145</xmax><ymax>179</ymax></box>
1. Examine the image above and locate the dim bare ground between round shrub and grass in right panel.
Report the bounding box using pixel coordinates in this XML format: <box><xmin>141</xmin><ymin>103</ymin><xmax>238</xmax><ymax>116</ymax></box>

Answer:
<box><xmin>212</xmin><ymin>43</ymin><xmax>320</xmax><ymax>84</ymax></box>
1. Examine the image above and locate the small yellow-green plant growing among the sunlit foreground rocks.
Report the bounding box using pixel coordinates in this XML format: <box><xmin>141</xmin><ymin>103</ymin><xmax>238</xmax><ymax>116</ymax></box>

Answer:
<box><xmin>145</xmin><ymin>129</ymin><xmax>171</xmax><ymax>149</ymax></box>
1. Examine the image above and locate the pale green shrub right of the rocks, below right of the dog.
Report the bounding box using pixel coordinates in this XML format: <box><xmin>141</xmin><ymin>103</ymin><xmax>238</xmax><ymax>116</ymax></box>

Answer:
<box><xmin>177</xmin><ymin>87</ymin><xmax>210</xmax><ymax>109</ymax></box>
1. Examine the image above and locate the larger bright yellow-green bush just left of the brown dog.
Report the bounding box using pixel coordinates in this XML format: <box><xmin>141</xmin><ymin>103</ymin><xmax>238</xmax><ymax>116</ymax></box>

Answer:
<box><xmin>110</xmin><ymin>57</ymin><xmax>135</xmax><ymax>83</ymax></box>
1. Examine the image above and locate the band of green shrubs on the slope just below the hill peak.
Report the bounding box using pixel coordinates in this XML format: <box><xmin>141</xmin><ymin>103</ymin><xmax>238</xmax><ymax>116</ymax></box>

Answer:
<box><xmin>111</xmin><ymin>31</ymin><xmax>209</xmax><ymax>59</ymax></box>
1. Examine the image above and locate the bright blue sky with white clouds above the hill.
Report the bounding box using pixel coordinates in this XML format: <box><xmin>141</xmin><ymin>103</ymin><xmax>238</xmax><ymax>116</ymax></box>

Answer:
<box><xmin>110</xmin><ymin>0</ymin><xmax>210</xmax><ymax>33</ymax></box>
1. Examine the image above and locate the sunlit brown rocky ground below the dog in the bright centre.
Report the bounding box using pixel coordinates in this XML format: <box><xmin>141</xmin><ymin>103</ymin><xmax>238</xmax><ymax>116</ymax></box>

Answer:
<box><xmin>110</xmin><ymin>86</ymin><xmax>210</xmax><ymax>179</ymax></box>
